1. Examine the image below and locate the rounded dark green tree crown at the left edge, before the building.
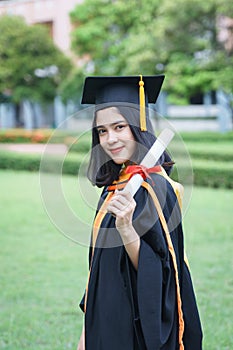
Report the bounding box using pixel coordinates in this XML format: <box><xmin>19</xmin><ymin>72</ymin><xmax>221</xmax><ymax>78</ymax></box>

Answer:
<box><xmin>0</xmin><ymin>15</ymin><xmax>71</xmax><ymax>103</ymax></box>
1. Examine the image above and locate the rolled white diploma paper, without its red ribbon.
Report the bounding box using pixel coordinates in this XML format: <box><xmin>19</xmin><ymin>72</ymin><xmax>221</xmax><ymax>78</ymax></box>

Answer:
<box><xmin>123</xmin><ymin>129</ymin><xmax>174</xmax><ymax>196</ymax></box>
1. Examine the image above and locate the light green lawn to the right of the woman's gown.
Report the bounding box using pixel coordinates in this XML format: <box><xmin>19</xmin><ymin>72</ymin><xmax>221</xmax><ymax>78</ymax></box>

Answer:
<box><xmin>184</xmin><ymin>188</ymin><xmax>233</xmax><ymax>350</ymax></box>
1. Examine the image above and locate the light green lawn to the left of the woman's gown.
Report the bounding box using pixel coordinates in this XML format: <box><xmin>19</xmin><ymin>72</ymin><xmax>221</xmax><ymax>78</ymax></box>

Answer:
<box><xmin>0</xmin><ymin>171</ymin><xmax>87</xmax><ymax>350</ymax></box>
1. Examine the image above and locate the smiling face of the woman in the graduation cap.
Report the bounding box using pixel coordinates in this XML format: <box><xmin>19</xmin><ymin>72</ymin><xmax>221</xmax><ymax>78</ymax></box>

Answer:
<box><xmin>96</xmin><ymin>107</ymin><xmax>136</xmax><ymax>164</ymax></box>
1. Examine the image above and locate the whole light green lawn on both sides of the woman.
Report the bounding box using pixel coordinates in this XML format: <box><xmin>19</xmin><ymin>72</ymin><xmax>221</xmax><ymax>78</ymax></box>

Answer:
<box><xmin>0</xmin><ymin>171</ymin><xmax>233</xmax><ymax>350</ymax></box>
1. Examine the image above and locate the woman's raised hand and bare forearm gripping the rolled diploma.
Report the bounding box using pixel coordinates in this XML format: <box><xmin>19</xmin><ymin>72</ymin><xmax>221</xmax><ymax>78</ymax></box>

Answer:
<box><xmin>107</xmin><ymin>191</ymin><xmax>140</xmax><ymax>270</ymax></box>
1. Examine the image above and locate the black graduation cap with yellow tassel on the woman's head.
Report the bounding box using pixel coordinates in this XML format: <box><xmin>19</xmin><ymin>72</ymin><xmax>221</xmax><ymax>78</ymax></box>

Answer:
<box><xmin>81</xmin><ymin>74</ymin><xmax>165</xmax><ymax>131</ymax></box>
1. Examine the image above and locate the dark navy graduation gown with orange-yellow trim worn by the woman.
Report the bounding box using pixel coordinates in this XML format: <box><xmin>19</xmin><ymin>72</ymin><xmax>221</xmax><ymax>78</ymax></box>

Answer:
<box><xmin>80</xmin><ymin>171</ymin><xmax>202</xmax><ymax>350</ymax></box>
